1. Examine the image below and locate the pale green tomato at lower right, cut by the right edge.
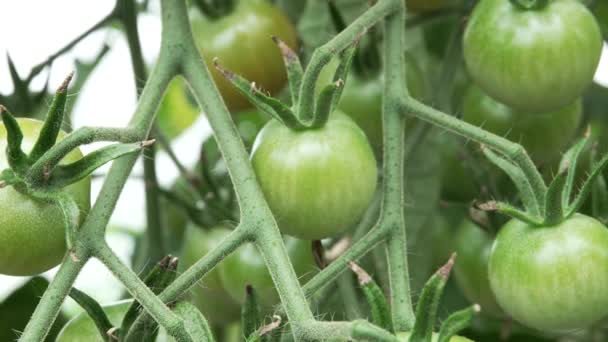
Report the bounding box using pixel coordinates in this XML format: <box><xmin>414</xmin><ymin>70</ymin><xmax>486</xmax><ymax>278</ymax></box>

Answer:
<box><xmin>488</xmin><ymin>214</ymin><xmax>608</xmax><ymax>332</ymax></box>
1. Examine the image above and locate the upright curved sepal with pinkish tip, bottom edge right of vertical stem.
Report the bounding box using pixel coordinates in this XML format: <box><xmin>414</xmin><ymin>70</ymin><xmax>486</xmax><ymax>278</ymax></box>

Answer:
<box><xmin>409</xmin><ymin>254</ymin><xmax>456</xmax><ymax>342</ymax></box>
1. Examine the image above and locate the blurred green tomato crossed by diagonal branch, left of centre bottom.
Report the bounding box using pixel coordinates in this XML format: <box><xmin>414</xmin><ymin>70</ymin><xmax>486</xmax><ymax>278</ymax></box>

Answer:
<box><xmin>179</xmin><ymin>225</ymin><xmax>240</xmax><ymax>325</ymax></box>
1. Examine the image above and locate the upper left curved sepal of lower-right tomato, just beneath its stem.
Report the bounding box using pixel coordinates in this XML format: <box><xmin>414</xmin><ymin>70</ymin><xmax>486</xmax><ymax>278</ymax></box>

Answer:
<box><xmin>481</xmin><ymin>146</ymin><xmax>541</xmax><ymax>216</ymax></box>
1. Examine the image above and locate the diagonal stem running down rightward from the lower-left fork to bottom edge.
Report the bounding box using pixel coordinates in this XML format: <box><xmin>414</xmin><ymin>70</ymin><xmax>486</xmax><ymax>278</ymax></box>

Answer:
<box><xmin>93</xmin><ymin>242</ymin><xmax>192</xmax><ymax>341</ymax></box>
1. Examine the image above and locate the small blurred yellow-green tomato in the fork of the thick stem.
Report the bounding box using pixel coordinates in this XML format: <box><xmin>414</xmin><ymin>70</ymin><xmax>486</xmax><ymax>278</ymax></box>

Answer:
<box><xmin>156</xmin><ymin>78</ymin><xmax>200</xmax><ymax>139</ymax></box>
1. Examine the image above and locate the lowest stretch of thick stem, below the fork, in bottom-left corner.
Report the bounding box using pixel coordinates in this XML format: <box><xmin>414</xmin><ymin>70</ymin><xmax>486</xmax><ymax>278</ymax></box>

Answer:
<box><xmin>19</xmin><ymin>245</ymin><xmax>90</xmax><ymax>342</ymax></box>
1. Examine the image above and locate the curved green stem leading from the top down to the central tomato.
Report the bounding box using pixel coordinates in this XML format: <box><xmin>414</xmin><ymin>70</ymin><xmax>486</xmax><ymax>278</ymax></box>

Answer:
<box><xmin>296</xmin><ymin>0</ymin><xmax>403</xmax><ymax>122</ymax></box>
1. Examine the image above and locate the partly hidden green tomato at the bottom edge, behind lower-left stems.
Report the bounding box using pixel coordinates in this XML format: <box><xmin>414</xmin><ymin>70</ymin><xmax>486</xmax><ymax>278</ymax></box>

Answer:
<box><xmin>55</xmin><ymin>299</ymin><xmax>133</xmax><ymax>342</ymax></box>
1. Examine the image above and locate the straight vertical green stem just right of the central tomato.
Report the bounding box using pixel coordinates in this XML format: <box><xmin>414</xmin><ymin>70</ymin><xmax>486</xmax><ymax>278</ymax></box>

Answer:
<box><xmin>380</xmin><ymin>1</ymin><xmax>415</xmax><ymax>331</ymax></box>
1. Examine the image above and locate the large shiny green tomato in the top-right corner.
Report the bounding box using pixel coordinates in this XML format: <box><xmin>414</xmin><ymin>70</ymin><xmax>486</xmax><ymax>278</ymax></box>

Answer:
<box><xmin>463</xmin><ymin>0</ymin><xmax>602</xmax><ymax>113</ymax></box>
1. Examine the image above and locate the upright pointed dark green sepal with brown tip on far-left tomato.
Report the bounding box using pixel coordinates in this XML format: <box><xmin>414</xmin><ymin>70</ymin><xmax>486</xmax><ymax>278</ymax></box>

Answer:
<box><xmin>29</xmin><ymin>74</ymin><xmax>73</xmax><ymax>163</ymax></box>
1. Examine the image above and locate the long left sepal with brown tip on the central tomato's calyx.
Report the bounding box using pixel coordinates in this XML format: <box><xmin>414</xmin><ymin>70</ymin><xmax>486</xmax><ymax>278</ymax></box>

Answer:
<box><xmin>213</xmin><ymin>58</ymin><xmax>304</xmax><ymax>130</ymax></box>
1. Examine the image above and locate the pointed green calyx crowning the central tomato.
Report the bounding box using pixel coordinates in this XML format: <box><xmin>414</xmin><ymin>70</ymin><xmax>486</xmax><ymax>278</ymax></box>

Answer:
<box><xmin>213</xmin><ymin>31</ymin><xmax>359</xmax><ymax>131</ymax></box>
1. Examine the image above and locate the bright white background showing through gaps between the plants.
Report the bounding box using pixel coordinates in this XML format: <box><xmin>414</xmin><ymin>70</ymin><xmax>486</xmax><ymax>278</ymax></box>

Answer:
<box><xmin>0</xmin><ymin>0</ymin><xmax>608</xmax><ymax>313</ymax></box>
